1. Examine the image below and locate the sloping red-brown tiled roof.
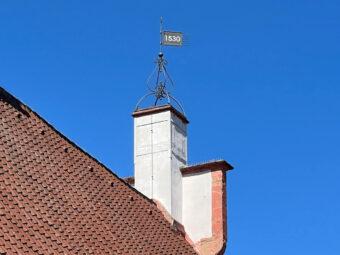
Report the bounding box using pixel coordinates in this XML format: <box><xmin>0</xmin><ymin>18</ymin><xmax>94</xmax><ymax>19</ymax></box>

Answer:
<box><xmin>0</xmin><ymin>88</ymin><xmax>196</xmax><ymax>254</ymax></box>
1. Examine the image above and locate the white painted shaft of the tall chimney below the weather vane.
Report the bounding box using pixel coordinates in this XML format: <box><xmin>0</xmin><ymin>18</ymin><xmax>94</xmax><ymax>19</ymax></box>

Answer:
<box><xmin>134</xmin><ymin>111</ymin><xmax>187</xmax><ymax>222</ymax></box>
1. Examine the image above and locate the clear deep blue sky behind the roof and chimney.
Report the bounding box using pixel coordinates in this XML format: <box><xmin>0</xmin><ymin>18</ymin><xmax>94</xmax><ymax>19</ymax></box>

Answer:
<box><xmin>0</xmin><ymin>0</ymin><xmax>340</xmax><ymax>255</ymax></box>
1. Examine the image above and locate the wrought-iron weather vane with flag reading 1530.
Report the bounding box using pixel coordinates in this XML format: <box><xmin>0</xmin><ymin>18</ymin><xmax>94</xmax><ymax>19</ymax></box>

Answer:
<box><xmin>136</xmin><ymin>17</ymin><xmax>184</xmax><ymax>114</ymax></box>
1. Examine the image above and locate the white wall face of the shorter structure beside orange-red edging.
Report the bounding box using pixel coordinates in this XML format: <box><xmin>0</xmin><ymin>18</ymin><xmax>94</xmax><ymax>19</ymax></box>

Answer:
<box><xmin>182</xmin><ymin>171</ymin><xmax>212</xmax><ymax>243</ymax></box>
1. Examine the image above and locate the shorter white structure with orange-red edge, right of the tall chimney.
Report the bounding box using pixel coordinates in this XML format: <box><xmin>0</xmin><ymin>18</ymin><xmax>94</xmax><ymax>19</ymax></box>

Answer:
<box><xmin>181</xmin><ymin>160</ymin><xmax>233</xmax><ymax>255</ymax></box>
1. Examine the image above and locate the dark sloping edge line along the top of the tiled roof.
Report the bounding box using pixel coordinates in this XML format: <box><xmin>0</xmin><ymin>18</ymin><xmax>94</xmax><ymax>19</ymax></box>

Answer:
<box><xmin>0</xmin><ymin>86</ymin><xmax>157</xmax><ymax>208</ymax></box>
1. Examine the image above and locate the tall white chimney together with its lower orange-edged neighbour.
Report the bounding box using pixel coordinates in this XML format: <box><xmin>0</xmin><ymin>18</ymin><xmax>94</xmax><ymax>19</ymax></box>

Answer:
<box><xmin>130</xmin><ymin>104</ymin><xmax>233</xmax><ymax>255</ymax></box>
